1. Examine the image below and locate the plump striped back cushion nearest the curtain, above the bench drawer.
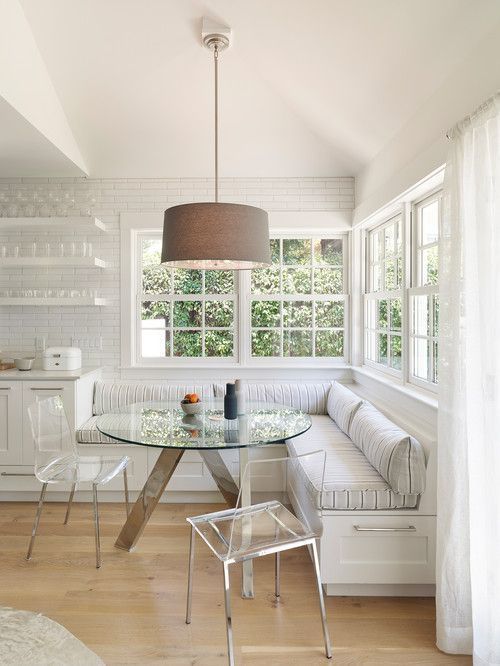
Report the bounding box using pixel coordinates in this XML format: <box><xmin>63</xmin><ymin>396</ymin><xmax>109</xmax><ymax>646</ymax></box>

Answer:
<box><xmin>349</xmin><ymin>402</ymin><xmax>425</xmax><ymax>495</ymax></box>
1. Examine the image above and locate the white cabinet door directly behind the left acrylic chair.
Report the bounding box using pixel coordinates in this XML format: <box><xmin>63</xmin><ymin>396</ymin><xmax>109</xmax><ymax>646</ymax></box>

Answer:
<box><xmin>22</xmin><ymin>380</ymin><xmax>75</xmax><ymax>465</ymax></box>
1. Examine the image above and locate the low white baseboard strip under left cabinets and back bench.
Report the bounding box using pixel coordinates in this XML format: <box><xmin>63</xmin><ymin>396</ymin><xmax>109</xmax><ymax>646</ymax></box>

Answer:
<box><xmin>0</xmin><ymin>490</ymin><xmax>225</xmax><ymax>504</ymax></box>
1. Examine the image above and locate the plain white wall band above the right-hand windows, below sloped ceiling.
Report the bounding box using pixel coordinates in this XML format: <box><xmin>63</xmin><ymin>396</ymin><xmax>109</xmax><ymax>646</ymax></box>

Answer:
<box><xmin>353</xmin><ymin>24</ymin><xmax>500</xmax><ymax>224</ymax></box>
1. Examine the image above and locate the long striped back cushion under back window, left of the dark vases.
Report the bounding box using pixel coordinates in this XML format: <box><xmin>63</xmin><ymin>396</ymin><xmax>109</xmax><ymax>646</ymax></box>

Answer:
<box><xmin>93</xmin><ymin>381</ymin><xmax>214</xmax><ymax>416</ymax></box>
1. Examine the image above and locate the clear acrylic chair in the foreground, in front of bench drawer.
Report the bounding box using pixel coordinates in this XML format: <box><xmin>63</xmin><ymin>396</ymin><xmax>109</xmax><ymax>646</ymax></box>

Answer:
<box><xmin>186</xmin><ymin>451</ymin><xmax>332</xmax><ymax>666</ymax></box>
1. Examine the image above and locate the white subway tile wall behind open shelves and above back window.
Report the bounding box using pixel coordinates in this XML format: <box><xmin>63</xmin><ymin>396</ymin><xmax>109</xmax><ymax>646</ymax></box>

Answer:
<box><xmin>0</xmin><ymin>177</ymin><xmax>354</xmax><ymax>378</ymax></box>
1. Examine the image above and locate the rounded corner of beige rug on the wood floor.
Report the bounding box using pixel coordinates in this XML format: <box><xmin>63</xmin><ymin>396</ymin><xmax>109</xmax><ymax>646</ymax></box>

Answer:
<box><xmin>0</xmin><ymin>608</ymin><xmax>104</xmax><ymax>666</ymax></box>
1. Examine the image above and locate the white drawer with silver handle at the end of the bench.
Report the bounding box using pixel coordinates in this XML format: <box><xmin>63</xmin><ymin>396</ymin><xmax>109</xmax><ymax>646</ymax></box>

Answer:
<box><xmin>321</xmin><ymin>513</ymin><xmax>436</xmax><ymax>584</ymax></box>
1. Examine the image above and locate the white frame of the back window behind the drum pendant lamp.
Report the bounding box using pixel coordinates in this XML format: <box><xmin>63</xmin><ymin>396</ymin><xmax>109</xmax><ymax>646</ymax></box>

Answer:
<box><xmin>119</xmin><ymin>212</ymin><xmax>351</xmax><ymax>370</ymax></box>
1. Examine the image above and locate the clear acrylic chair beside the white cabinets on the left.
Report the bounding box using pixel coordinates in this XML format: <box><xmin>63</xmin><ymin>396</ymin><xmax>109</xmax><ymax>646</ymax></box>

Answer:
<box><xmin>26</xmin><ymin>396</ymin><xmax>130</xmax><ymax>569</ymax></box>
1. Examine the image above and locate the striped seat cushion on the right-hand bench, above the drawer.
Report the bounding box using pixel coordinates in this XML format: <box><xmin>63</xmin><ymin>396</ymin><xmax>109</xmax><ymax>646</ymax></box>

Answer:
<box><xmin>286</xmin><ymin>416</ymin><xmax>418</xmax><ymax>511</ymax></box>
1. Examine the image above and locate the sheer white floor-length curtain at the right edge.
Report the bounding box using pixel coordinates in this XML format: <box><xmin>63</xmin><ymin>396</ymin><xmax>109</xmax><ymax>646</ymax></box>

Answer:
<box><xmin>436</xmin><ymin>93</ymin><xmax>500</xmax><ymax>666</ymax></box>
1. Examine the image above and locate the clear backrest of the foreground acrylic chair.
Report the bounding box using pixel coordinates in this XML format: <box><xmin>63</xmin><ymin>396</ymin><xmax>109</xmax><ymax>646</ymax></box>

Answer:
<box><xmin>226</xmin><ymin>450</ymin><xmax>326</xmax><ymax>558</ymax></box>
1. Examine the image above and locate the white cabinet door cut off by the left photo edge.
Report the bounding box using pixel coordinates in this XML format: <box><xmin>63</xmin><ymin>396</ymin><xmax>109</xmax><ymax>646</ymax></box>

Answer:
<box><xmin>0</xmin><ymin>381</ymin><xmax>23</xmax><ymax>465</ymax></box>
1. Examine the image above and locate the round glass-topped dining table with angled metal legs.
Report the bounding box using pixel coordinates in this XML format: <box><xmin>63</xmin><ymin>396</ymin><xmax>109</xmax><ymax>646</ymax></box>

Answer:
<box><xmin>96</xmin><ymin>398</ymin><xmax>311</xmax><ymax>597</ymax></box>
